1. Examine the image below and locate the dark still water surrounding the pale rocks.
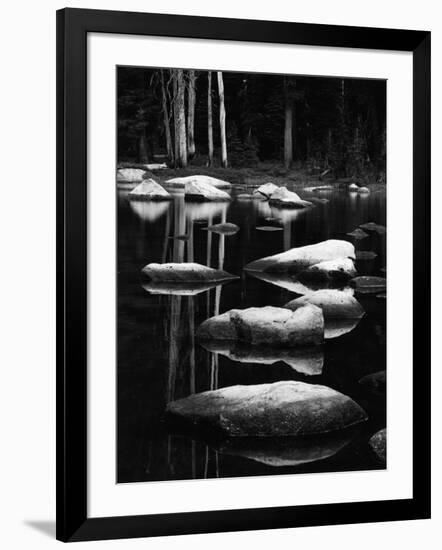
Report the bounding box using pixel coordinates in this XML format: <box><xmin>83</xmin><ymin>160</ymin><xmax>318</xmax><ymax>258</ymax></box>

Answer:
<box><xmin>117</xmin><ymin>184</ymin><xmax>386</xmax><ymax>482</ymax></box>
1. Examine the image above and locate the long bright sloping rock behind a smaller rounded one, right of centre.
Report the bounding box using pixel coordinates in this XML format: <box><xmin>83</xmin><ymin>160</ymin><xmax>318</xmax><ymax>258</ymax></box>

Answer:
<box><xmin>244</xmin><ymin>239</ymin><xmax>355</xmax><ymax>273</ymax></box>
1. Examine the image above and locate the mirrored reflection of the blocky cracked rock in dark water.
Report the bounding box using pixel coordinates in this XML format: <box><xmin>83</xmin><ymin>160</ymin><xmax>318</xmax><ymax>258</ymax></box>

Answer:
<box><xmin>201</xmin><ymin>340</ymin><xmax>324</xmax><ymax>376</ymax></box>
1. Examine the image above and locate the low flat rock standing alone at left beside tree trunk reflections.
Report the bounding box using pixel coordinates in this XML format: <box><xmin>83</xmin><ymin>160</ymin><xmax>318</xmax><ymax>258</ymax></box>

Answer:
<box><xmin>142</xmin><ymin>262</ymin><xmax>238</xmax><ymax>283</ymax></box>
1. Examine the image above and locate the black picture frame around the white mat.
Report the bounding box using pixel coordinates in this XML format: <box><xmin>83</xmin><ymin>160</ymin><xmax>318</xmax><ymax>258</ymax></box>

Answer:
<box><xmin>57</xmin><ymin>9</ymin><xmax>430</xmax><ymax>541</ymax></box>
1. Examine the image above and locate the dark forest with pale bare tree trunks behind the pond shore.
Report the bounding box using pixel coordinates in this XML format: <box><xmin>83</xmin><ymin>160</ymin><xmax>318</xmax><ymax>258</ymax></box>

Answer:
<box><xmin>117</xmin><ymin>67</ymin><xmax>386</xmax><ymax>182</ymax></box>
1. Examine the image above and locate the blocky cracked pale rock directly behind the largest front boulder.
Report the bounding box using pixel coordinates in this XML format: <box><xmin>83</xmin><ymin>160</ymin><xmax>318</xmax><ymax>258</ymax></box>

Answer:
<box><xmin>197</xmin><ymin>304</ymin><xmax>324</xmax><ymax>347</ymax></box>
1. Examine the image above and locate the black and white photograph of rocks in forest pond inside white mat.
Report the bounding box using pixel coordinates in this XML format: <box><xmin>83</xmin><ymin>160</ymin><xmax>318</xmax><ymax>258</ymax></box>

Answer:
<box><xmin>116</xmin><ymin>66</ymin><xmax>388</xmax><ymax>483</ymax></box>
